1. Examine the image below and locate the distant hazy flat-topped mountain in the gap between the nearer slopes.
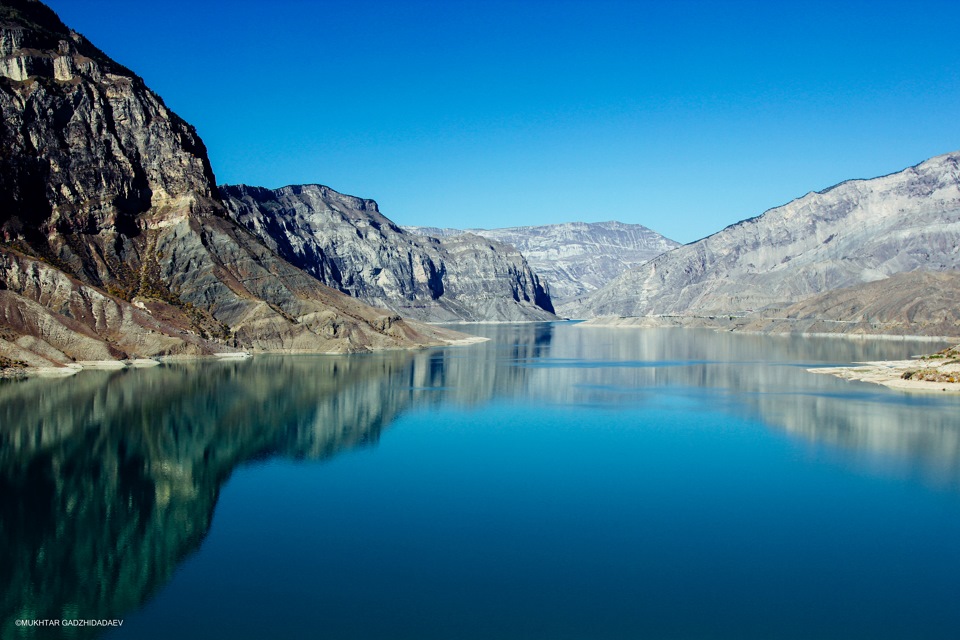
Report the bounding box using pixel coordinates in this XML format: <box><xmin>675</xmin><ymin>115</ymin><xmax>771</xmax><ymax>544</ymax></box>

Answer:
<box><xmin>404</xmin><ymin>221</ymin><xmax>680</xmax><ymax>315</ymax></box>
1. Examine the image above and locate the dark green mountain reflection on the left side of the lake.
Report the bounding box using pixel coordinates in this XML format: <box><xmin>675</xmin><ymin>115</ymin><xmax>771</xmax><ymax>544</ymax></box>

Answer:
<box><xmin>0</xmin><ymin>353</ymin><xmax>428</xmax><ymax>638</ymax></box>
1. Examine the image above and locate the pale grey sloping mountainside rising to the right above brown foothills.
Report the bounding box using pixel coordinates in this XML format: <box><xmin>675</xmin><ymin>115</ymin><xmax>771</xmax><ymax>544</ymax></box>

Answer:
<box><xmin>578</xmin><ymin>152</ymin><xmax>960</xmax><ymax>317</ymax></box>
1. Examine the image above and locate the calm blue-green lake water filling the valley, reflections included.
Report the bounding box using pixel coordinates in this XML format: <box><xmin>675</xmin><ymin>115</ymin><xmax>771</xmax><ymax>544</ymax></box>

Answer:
<box><xmin>0</xmin><ymin>324</ymin><xmax>960</xmax><ymax>640</ymax></box>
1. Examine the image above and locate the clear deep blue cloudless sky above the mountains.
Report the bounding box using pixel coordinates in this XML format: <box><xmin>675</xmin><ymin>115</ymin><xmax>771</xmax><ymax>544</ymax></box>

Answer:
<box><xmin>49</xmin><ymin>0</ymin><xmax>960</xmax><ymax>242</ymax></box>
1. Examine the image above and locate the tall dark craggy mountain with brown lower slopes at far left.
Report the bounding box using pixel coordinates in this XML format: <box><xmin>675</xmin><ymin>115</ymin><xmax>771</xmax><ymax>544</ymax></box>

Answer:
<box><xmin>0</xmin><ymin>0</ymin><xmax>464</xmax><ymax>364</ymax></box>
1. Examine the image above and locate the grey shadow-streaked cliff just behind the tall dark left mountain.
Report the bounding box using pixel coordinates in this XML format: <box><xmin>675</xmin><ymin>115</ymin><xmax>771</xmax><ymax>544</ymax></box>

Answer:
<box><xmin>220</xmin><ymin>185</ymin><xmax>556</xmax><ymax>322</ymax></box>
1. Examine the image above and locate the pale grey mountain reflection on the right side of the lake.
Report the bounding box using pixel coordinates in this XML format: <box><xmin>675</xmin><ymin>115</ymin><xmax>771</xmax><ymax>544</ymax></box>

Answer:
<box><xmin>556</xmin><ymin>327</ymin><xmax>960</xmax><ymax>489</ymax></box>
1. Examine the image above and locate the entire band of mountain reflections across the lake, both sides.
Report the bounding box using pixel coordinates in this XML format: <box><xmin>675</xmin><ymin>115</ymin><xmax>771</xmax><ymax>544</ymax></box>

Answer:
<box><xmin>0</xmin><ymin>324</ymin><xmax>960</xmax><ymax>637</ymax></box>
